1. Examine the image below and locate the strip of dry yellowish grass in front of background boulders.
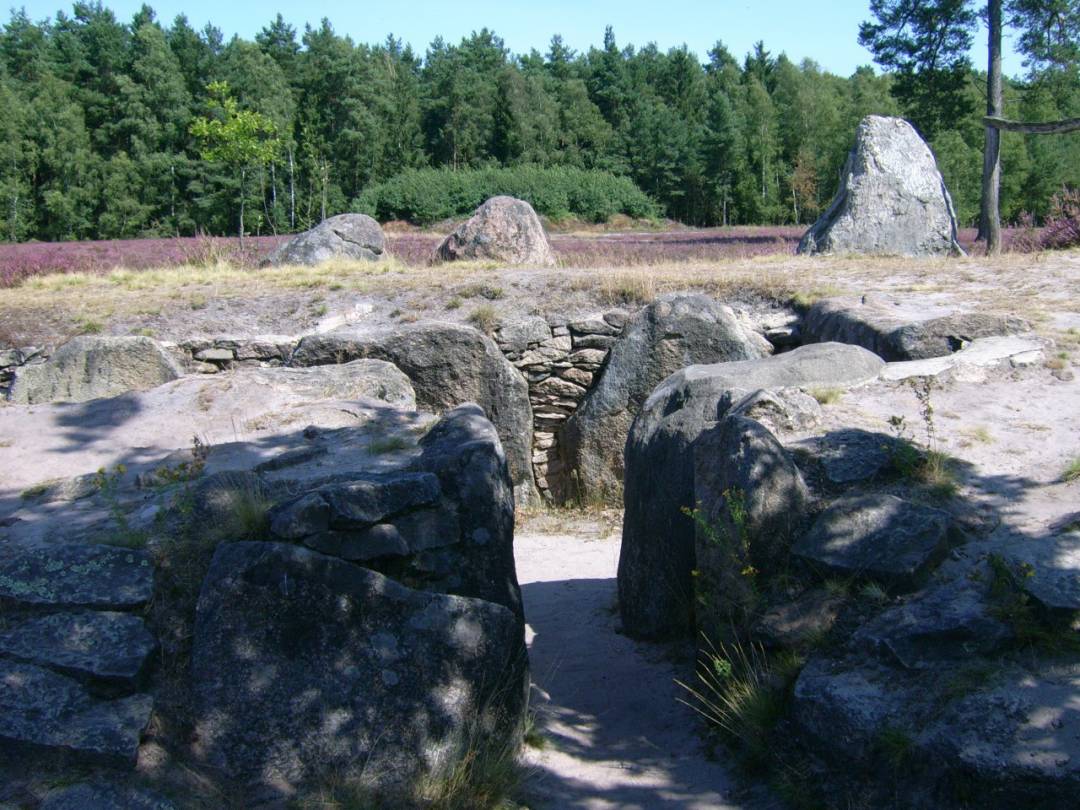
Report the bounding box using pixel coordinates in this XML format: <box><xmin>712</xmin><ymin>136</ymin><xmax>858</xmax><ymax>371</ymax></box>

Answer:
<box><xmin>0</xmin><ymin>251</ymin><xmax>1080</xmax><ymax>345</ymax></box>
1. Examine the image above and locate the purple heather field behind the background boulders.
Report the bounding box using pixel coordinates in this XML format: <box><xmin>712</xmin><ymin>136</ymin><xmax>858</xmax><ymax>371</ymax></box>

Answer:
<box><xmin>0</xmin><ymin>226</ymin><xmax>1037</xmax><ymax>287</ymax></box>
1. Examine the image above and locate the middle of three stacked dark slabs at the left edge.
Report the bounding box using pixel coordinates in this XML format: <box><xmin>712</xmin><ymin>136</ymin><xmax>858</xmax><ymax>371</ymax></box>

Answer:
<box><xmin>0</xmin><ymin>611</ymin><xmax>157</xmax><ymax>691</ymax></box>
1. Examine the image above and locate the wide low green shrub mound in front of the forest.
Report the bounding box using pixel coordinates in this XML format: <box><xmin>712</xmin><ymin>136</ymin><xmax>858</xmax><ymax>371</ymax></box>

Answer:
<box><xmin>352</xmin><ymin>165</ymin><xmax>659</xmax><ymax>225</ymax></box>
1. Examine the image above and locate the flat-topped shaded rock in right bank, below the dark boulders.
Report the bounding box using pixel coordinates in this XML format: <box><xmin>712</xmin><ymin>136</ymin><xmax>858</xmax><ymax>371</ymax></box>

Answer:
<box><xmin>792</xmin><ymin>494</ymin><xmax>949</xmax><ymax>591</ymax></box>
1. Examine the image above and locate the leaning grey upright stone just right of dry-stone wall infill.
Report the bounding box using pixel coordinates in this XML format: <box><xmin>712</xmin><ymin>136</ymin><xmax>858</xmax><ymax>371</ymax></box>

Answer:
<box><xmin>556</xmin><ymin>295</ymin><xmax>766</xmax><ymax>499</ymax></box>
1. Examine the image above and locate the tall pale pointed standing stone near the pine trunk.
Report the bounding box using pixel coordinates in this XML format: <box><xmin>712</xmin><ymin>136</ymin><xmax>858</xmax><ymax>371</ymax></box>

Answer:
<box><xmin>799</xmin><ymin>116</ymin><xmax>961</xmax><ymax>256</ymax></box>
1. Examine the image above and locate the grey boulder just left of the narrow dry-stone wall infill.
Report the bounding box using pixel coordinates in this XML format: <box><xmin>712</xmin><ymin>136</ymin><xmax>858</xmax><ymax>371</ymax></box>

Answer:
<box><xmin>293</xmin><ymin>323</ymin><xmax>536</xmax><ymax>502</ymax></box>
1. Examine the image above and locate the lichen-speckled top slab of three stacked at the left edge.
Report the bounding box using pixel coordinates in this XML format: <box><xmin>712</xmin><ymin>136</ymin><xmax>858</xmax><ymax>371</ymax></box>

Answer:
<box><xmin>0</xmin><ymin>543</ymin><xmax>153</xmax><ymax>610</ymax></box>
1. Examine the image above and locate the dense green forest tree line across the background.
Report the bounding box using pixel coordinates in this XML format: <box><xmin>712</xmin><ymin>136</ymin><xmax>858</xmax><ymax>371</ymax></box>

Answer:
<box><xmin>0</xmin><ymin>2</ymin><xmax>1080</xmax><ymax>240</ymax></box>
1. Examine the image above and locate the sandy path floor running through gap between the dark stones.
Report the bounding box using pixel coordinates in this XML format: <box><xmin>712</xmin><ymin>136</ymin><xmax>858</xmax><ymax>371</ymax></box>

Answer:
<box><xmin>514</xmin><ymin>523</ymin><xmax>767</xmax><ymax>810</ymax></box>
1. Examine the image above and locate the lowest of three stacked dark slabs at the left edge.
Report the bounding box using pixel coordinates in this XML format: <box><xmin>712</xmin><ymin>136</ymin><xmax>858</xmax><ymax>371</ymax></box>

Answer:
<box><xmin>0</xmin><ymin>659</ymin><xmax>153</xmax><ymax>767</ymax></box>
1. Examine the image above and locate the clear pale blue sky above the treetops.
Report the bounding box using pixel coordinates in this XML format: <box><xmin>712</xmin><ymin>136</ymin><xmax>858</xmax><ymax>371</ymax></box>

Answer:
<box><xmin>19</xmin><ymin>0</ymin><xmax>1023</xmax><ymax>76</ymax></box>
